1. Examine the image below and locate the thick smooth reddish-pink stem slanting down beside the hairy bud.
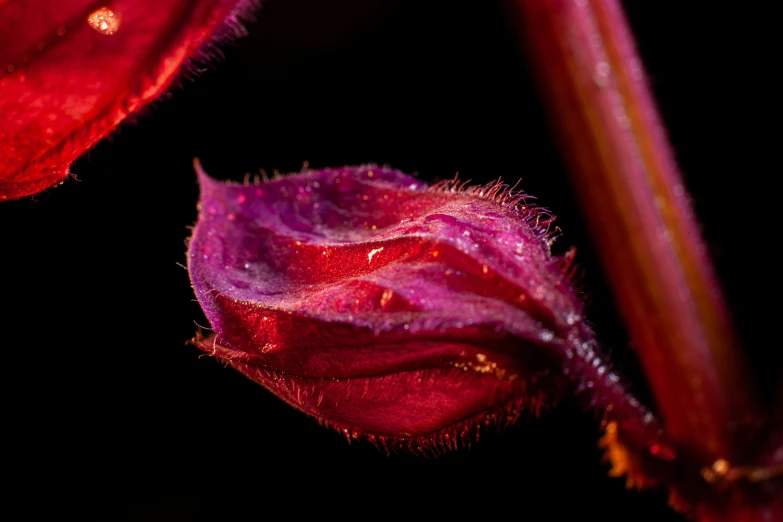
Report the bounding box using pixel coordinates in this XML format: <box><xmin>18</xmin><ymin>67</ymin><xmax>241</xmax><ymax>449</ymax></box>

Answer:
<box><xmin>508</xmin><ymin>0</ymin><xmax>765</xmax><ymax>465</ymax></box>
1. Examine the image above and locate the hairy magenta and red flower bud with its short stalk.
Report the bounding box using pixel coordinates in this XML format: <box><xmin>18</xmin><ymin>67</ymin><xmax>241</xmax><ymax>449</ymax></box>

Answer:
<box><xmin>188</xmin><ymin>161</ymin><xmax>655</xmax><ymax>451</ymax></box>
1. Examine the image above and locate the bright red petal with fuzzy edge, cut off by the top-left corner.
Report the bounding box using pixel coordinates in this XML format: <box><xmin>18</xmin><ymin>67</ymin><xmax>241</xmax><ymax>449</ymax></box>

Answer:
<box><xmin>0</xmin><ymin>0</ymin><xmax>252</xmax><ymax>200</ymax></box>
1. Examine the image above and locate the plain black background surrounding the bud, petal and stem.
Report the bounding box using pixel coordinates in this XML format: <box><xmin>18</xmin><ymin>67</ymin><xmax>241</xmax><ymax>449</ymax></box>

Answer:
<box><xmin>0</xmin><ymin>0</ymin><xmax>780</xmax><ymax>521</ymax></box>
